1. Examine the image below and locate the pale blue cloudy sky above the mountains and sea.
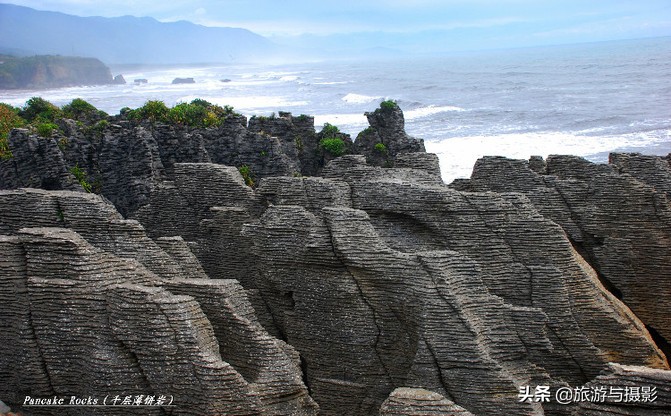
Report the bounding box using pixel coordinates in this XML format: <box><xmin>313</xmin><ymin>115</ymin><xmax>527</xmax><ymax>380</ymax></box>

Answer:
<box><xmin>7</xmin><ymin>0</ymin><xmax>671</xmax><ymax>50</ymax></box>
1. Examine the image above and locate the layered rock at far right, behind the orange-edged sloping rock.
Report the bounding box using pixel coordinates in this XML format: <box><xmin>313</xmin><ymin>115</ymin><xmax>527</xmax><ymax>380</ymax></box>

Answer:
<box><xmin>458</xmin><ymin>154</ymin><xmax>671</xmax><ymax>354</ymax></box>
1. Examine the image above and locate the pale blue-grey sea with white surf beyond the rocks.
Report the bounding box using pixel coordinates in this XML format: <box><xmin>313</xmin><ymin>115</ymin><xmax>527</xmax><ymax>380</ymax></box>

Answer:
<box><xmin>0</xmin><ymin>37</ymin><xmax>671</xmax><ymax>183</ymax></box>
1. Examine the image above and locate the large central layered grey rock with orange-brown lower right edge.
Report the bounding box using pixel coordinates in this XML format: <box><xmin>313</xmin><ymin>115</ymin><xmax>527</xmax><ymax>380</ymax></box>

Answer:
<box><xmin>130</xmin><ymin>156</ymin><xmax>667</xmax><ymax>415</ymax></box>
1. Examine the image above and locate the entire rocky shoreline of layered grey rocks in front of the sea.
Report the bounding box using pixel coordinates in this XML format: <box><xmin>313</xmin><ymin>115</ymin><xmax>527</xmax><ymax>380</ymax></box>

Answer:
<box><xmin>0</xmin><ymin>103</ymin><xmax>671</xmax><ymax>416</ymax></box>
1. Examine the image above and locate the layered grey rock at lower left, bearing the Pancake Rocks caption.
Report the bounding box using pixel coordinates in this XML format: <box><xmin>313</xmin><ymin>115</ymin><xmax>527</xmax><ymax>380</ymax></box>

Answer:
<box><xmin>0</xmin><ymin>190</ymin><xmax>318</xmax><ymax>415</ymax></box>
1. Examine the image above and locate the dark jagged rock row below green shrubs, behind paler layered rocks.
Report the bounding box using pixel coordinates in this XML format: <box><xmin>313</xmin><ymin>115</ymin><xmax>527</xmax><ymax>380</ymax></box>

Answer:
<box><xmin>0</xmin><ymin>104</ymin><xmax>440</xmax><ymax>216</ymax></box>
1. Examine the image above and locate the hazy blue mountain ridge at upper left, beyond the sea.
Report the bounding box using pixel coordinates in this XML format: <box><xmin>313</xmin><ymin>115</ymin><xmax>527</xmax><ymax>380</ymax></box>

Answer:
<box><xmin>0</xmin><ymin>4</ymin><xmax>277</xmax><ymax>64</ymax></box>
